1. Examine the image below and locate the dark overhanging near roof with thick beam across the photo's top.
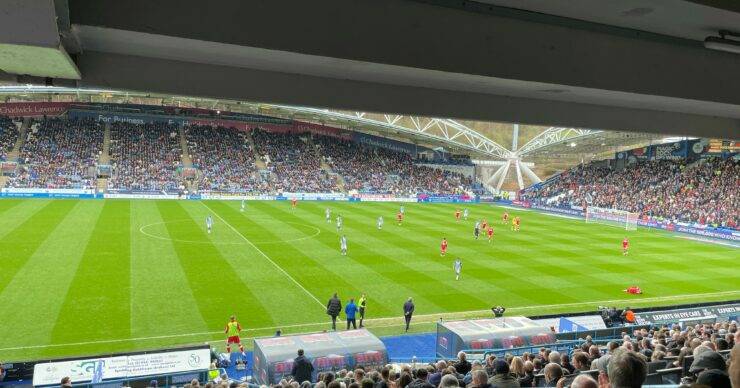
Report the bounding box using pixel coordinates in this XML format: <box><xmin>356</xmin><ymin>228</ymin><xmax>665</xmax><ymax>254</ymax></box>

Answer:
<box><xmin>0</xmin><ymin>0</ymin><xmax>740</xmax><ymax>139</ymax></box>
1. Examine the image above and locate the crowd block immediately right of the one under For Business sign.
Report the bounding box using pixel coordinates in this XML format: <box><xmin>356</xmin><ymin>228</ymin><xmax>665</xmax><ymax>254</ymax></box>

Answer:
<box><xmin>185</xmin><ymin>125</ymin><xmax>261</xmax><ymax>193</ymax></box>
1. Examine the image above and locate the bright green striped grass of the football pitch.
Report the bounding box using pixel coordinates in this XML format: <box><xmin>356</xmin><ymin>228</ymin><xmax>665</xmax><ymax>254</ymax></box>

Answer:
<box><xmin>0</xmin><ymin>199</ymin><xmax>740</xmax><ymax>361</ymax></box>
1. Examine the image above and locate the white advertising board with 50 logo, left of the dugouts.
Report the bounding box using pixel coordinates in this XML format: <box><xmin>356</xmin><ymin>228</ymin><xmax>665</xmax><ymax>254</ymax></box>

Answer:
<box><xmin>33</xmin><ymin>347</ymin><xmax>211</xmax><ymax>387</ymax></box>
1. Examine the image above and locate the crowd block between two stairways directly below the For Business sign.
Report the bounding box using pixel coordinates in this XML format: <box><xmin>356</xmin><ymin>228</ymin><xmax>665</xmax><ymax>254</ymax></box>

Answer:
<box><xmin>108</xmin><ymin>122</ymin><xmax>182</xmax><ymax>193</ymax></box>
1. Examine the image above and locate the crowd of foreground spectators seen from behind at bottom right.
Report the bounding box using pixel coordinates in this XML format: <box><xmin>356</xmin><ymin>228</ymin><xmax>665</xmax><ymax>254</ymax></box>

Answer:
<box><xmin>250</xmin><ymin>322</ymin><xmax>740</xmax><ymax>388</ymax></box>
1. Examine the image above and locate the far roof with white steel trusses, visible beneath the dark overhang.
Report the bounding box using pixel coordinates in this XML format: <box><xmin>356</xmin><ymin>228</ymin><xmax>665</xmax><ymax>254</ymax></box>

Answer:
<box><xmin>0</xmin><ymin>85</ymin><xmax>661</xmax><ymax>160</ymax></box>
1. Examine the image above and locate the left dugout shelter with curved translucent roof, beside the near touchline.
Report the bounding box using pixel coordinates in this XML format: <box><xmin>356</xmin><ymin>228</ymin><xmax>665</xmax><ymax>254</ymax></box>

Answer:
<box><xmin>252</xmin><ymin>329</ymin><xmax>388</xmax><ymax>384</ymax></box>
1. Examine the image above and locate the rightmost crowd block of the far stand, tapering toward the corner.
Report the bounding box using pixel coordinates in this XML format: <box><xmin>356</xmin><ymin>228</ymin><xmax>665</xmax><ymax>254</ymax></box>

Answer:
<box><xmin>316</xmin><ymin>136</ymin><xmax>472</xmax><ymax>195</ymax></box>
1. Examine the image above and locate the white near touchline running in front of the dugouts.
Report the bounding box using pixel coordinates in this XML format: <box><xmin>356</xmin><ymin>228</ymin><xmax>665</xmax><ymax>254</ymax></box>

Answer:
<box><xmin>0</xmin><ymin>290</ymin><xmax>740</xmax><ymax>352</ymax></box>
